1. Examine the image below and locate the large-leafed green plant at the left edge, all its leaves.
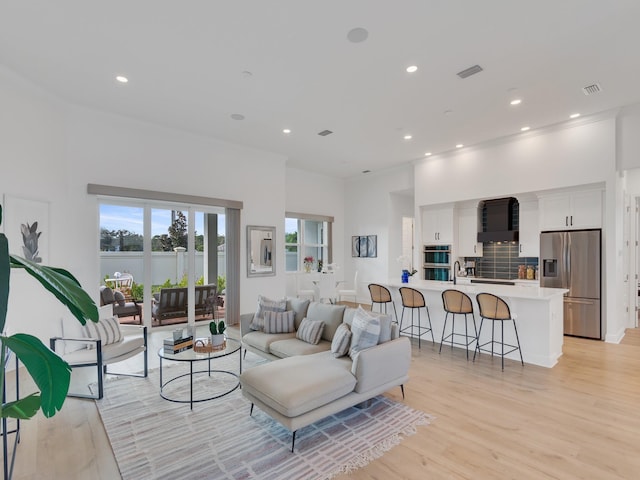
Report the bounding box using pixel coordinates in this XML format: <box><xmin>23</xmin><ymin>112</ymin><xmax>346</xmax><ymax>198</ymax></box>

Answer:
<box><xmin>0</xmin><ymin>206</ymin><xmax>98</xmax><ymax>419</ymax></box>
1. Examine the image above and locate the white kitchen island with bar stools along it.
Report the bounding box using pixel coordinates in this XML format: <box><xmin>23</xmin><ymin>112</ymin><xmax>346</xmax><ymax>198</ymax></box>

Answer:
<box><xmin>382</xmin><ymin>279</ymin><xmax>568</xmax><ymax>368</ymax></box>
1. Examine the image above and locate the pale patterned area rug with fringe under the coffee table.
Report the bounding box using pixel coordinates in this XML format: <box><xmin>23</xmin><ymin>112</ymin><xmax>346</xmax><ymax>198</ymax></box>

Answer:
<box><xmin>96</xmin><ymin>359</ymin><xmax>432</xmax><ymax>480</ymax></box>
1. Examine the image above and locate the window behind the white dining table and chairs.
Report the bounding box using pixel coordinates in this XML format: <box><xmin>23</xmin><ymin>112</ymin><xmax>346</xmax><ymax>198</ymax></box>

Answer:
<box><xmin>284</xmin><ymin>213</ymin><xmax>333</xmax><ymax>272</ymax></box>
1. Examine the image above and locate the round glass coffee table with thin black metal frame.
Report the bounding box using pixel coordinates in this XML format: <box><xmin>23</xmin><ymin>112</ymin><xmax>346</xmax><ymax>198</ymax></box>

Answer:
<box><xmin>158</xmin><ymin>338</ymin><xmax>242</xmax><ymax>410</ymax></box>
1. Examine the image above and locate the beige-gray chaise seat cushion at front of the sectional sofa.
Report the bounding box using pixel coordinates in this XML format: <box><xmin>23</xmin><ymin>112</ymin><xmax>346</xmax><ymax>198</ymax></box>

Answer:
<box><xmin>240</xmin><ymin>351</ymin><xmax>356</xmax><ymax>417</ymax></box>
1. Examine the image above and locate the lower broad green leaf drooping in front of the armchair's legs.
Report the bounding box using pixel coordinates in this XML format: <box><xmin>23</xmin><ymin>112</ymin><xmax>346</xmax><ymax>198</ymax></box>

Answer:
<box><xmin>0</xmin><ymin>333</ymin><xmax>71</xmax><ymax>417</ymax></box>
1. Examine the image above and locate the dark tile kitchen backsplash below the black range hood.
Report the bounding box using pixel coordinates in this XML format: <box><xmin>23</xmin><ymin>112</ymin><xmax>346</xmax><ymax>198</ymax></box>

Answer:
<box><xmin>465</xmin><ymin>243</ymin><xmax>538</xmax><ymax>280</ymax></box>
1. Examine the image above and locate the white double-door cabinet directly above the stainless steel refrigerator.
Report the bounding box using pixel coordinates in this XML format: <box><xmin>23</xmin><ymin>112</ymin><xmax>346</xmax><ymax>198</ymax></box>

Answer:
<box><xmin>540</xmin><ymin>190</ymin><xmax>602</xmax><ymax>230</ymax></box>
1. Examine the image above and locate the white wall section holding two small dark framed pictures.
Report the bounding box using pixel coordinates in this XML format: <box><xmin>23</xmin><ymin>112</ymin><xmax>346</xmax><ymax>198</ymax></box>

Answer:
<box><xmin>344</xmin><ymin>165</ymin><xmax>413</xmax><ymax>303</ymax></box>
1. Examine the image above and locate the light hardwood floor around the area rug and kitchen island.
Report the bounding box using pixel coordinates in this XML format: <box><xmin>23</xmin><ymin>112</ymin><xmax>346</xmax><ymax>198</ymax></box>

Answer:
<box><xmin>5</xmin><ymin>329</ymin><xmax>640</xmax><ymax>480</ymax></box>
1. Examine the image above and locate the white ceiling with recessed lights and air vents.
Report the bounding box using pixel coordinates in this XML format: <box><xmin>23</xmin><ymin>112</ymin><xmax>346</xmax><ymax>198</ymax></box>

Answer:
<box><xmin>0</xmin><ymin>0</ymin><xmax>640</xmax><ymax>177</ymax></box>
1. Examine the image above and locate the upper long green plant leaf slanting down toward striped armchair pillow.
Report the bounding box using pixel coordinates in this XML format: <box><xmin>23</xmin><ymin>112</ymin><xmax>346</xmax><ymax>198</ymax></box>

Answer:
<box><xmin>9</xmin><ymin>255</ymin><xmax>98</xmax><ymax>325</ymax></box>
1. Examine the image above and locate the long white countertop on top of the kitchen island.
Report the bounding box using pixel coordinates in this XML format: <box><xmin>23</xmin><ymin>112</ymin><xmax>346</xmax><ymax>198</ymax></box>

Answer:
<box><xmin>386</xmin><ymin>277</ymin><xmax>569</xmax><ymax>300</ymax></box>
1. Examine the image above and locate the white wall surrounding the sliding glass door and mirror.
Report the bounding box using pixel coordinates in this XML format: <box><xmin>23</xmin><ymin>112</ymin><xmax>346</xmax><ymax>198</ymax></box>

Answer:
<box><xmin>0</xmin><ymin>69</ymin><xmax>286</xmax><ymax>340</ymax></box>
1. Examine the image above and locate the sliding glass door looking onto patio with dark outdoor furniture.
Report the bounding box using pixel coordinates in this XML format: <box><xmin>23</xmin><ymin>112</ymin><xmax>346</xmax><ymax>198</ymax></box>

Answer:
<box><xmin>100</xmin><ymin>201</ymin><xmax>226</xmax><ymax>327</ymax></box>
